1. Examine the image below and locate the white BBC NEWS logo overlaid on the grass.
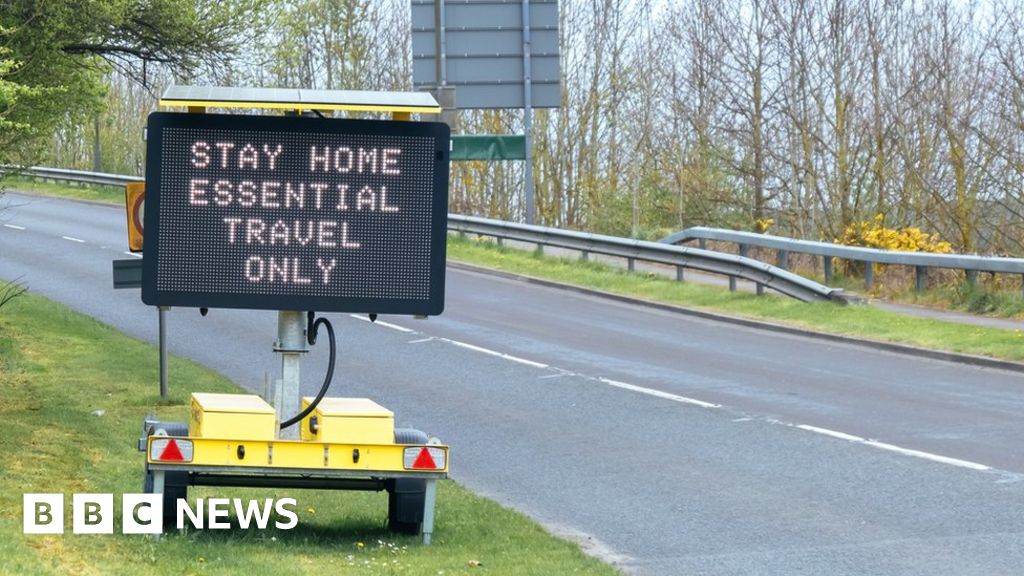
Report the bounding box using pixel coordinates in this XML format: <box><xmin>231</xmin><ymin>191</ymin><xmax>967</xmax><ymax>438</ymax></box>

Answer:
<box><xmin>22</xmin><ymin>494</ymin><xmax>299</xmax><ymax>534</ymax></box>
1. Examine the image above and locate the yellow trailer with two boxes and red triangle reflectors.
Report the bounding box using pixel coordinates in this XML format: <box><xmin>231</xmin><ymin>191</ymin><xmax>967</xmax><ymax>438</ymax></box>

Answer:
<box><xmin>139</xmin><ymin>394</ymin><xmax>449</xmax><ymax>544</ymax></box>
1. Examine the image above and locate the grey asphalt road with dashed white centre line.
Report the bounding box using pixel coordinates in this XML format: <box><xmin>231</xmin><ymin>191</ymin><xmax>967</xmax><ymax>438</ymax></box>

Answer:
<box><xmin>0</xmin><ymin>190</ymin><xmax>1024</xmax><ymax>575</ymax></box>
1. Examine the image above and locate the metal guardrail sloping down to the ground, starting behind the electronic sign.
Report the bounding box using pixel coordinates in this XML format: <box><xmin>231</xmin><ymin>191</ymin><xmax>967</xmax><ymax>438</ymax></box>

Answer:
<box><xmin>449</xmin><ymin>214</ymin><xmax>844</xmax><ymax>301</ymax></box>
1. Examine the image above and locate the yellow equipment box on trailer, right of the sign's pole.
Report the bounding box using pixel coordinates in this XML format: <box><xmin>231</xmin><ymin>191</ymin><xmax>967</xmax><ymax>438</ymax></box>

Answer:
<box><xmin>301</xmin><ymin>398</ymin><xmax>394</xmax><ymax>444</ymax></box>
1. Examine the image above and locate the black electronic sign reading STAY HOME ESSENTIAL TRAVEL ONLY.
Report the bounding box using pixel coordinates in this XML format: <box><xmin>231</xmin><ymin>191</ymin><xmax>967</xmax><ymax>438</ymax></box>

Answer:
<box><xmin>142</xmin><ymin>113</ymin><xmax>450</xmax><ymax>315</ymax></box>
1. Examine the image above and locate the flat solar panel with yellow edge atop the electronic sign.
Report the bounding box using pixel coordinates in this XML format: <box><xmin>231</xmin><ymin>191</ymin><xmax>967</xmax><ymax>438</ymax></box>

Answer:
<box><xmin>160</xmin><ymin>85</ymin><xmax>440</xmax><ymax>114</ymax></box>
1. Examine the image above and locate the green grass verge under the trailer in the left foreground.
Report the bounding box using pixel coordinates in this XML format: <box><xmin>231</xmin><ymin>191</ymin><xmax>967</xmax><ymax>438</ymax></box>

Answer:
<box><xmin>0</xmin><ymin>295</ymin><xmax>615</xmax><ymax>576</ymax></box>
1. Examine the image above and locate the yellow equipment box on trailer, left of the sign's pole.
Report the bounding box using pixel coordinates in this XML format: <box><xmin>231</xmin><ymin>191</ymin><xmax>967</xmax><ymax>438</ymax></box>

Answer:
<box><xmin>188</xmin><ymin>393</ymin><xmax>278</xmax><ymax>440</ymax></box>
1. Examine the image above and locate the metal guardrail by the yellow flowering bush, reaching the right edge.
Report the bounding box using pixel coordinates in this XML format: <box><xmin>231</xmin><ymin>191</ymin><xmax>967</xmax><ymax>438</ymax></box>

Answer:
<box><xmin>660</xmin><ymin>227</ymin><xmax>1024</xmax><ymax>292</ymax></box>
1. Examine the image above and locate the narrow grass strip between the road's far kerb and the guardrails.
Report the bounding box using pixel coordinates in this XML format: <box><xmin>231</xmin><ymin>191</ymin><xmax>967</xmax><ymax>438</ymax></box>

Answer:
<box><xmin>449</xmin><ymin>235</ymin><xmax>1024</xmax><ymax>361</ymax></box>
